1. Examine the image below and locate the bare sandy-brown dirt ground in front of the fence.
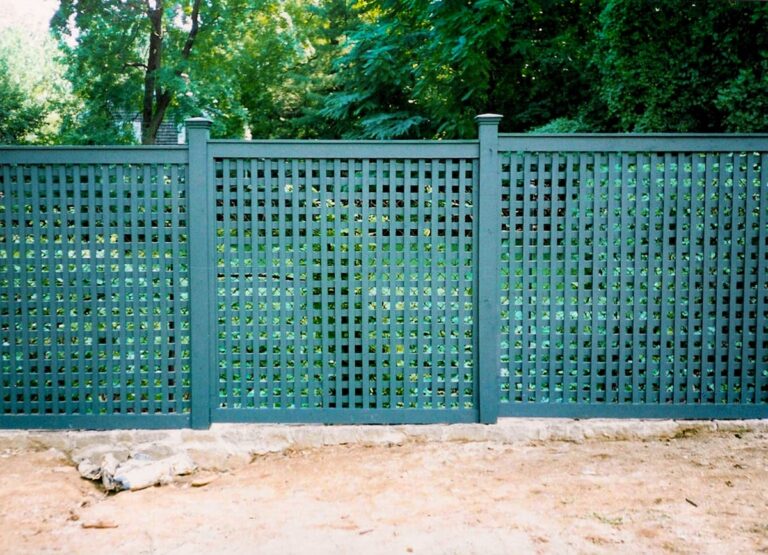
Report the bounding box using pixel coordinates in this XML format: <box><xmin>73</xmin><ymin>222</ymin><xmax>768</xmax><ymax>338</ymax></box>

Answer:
<box><xmin>0</xmin><ymin>432</ymin><xmax>768</xmax><ymax>555</ymax></box>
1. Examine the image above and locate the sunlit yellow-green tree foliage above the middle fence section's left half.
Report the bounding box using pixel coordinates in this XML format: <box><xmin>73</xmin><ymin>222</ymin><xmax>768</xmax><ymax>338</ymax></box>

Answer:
<box><xmin>231</xmin><ymin>0</ymin><xmax>360</xmax><ymax>139</ymax></box>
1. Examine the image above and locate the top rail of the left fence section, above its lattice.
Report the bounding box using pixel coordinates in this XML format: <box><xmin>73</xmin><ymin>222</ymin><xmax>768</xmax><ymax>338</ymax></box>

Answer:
<box><xmin>0</xmin><ymin>145</ymin><xmax>188</xmax><ymax>164</ymax></box>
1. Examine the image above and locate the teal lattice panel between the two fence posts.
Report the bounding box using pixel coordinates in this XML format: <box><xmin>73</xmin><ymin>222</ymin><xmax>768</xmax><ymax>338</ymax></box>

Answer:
<box><xmin>215</xmin><ymin>159</ymin><xmax>477</xmax><ymax>410</ymax></box>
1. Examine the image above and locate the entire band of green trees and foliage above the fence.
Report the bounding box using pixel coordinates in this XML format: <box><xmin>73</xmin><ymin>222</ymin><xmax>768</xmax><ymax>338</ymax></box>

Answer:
<box><xmin>0</xmin><ymin>0</ymin><xmax>756</xmax><ymax>143</ymax></box>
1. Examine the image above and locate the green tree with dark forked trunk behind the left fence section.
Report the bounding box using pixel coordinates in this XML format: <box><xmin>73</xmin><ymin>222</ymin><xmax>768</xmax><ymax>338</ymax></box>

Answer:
<box><xmin>51</xmin><ymin>0</ymin><xmax>254</xmax><ymax>144</ymax></box>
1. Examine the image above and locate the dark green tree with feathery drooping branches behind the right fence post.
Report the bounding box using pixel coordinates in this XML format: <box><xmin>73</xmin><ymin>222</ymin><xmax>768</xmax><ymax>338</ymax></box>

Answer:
<box><xmin>324</xmin><ymin>0</ymin><xmax>600</xmax><ymax>138</ymax></box>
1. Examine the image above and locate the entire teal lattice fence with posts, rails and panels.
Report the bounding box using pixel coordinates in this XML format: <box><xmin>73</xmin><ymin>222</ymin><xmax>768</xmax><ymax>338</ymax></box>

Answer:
<box><xmin>0</xmin><ymin>127</ymin><xmax>768</xmax><ymax>428</ymax></box>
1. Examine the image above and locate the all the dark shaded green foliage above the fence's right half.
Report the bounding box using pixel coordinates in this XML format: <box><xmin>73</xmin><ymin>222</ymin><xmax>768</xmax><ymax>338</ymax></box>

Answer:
<box><xmin>323</xmin><ymin>0</ymin><xmax>768</xmax><ymax>138</ymax></box>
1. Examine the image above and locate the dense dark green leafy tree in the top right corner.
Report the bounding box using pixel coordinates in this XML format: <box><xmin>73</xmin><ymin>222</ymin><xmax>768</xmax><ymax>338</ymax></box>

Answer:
<box><xmin>594</xmin><ymin>0</ymin><xmax>768</xmax><ymax>132</ymax></box>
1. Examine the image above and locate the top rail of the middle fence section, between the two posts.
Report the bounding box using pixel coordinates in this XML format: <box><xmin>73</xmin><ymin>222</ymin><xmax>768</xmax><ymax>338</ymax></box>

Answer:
<box><xmin>208</xmin><ymin>140</ymin><xmax>480</xmax><ymax>158</ymax></box>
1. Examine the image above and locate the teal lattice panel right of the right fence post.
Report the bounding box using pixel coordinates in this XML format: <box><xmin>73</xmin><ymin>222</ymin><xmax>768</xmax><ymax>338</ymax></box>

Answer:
<box><xmin>501</xmin><ymin>152</ymin><xmax>768</xmax><ymax>404</ymax></box>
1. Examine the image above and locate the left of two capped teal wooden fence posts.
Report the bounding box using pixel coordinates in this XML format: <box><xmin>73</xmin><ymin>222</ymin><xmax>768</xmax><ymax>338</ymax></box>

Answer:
<box><xmin>186</xmin><ymin>118</ymin><xmax>215</xmax><ymax>429</ymax></box>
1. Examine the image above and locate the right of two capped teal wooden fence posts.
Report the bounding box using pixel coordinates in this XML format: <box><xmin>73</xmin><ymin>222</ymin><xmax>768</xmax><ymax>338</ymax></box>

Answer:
<box><xmin>475</xmin><ymin>114</ymin><xmax>502</xmax><ymax>424</ymax></box>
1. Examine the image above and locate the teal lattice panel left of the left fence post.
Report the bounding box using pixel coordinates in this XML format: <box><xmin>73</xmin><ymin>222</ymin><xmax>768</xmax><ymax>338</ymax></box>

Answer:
<box><xmin>0</xmin><ymin>164</ymin><xmax>190</xmax><ymax>415</ymax></box>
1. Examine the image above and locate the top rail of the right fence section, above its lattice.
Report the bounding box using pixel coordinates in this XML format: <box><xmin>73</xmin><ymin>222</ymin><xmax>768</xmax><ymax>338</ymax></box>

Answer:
<box><xmin>499</xmin><ymin>133</ymin><xmax>768</xmax><ymax>152</ymax></box>
